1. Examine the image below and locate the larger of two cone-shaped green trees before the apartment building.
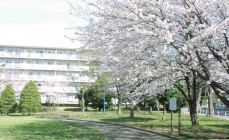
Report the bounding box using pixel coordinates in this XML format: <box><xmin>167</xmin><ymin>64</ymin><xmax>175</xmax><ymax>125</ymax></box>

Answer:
<box><xmin>19</xmin><ymin>81</ymin><xmax>41</xmax><ymax>115</ymax></box>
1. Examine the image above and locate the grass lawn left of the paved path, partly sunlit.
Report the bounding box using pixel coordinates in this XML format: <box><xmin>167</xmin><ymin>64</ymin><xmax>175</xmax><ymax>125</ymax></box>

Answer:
<box><xmin>0</xmin><ymin>115</ymin><xmax>107</xmax><ymax>140</ymax></box>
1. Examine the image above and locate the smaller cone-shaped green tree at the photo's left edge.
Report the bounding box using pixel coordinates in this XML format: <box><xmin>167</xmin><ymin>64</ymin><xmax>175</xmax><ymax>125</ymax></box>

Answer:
<box><xmin>0</xmin><ymin>84</ymin><xmax>17</xmax><ymax>115</ymax></box>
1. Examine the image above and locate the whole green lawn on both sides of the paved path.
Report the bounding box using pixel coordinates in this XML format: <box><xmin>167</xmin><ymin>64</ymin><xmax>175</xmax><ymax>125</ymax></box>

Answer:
<box><xmin>0</xmin><ymin>107</ymin><xmax>229</xmax><ymax>140</ymax></box>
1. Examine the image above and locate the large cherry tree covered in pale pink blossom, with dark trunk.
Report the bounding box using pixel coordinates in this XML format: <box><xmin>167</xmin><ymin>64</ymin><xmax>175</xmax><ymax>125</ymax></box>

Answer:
<box><xmin>71</xmin><ymin>0</ymin><xmax>229</xmax><ymax>125</ymax></box>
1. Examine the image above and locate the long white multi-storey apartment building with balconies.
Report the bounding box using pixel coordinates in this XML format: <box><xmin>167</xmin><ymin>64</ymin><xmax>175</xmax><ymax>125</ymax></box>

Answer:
<box><xmin>0</xmin><ymin>45</ymin><xmax>96</xmax><ymax>104</ymax></box>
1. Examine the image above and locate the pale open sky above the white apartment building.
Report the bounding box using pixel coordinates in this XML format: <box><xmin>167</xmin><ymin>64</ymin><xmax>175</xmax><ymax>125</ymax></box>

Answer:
<box><xmin>0</xmin><ymin>0</ymin><xmax>83</xmax><ymax>47</ymax></box>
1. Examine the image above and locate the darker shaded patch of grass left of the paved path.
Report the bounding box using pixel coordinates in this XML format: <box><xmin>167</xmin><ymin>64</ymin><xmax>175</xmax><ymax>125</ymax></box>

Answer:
<box><xmin>5</xmin><ymin>121</ymin><xmax>106</xmax><ymax>139</ymax></box>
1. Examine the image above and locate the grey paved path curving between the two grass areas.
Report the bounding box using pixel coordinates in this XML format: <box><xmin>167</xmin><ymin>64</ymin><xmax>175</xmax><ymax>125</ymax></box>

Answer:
<box><xmin>67</xmin><ymin>120</ymin><xmax>175</xmax><ymax>140</ymax></box>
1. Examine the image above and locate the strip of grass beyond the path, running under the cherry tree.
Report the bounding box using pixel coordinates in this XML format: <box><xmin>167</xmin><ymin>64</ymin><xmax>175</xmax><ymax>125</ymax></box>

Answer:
<box><xmin>41</xmin><ymin>107</ymin><xmax>229</xmax><ymax>139</ymax></box>
